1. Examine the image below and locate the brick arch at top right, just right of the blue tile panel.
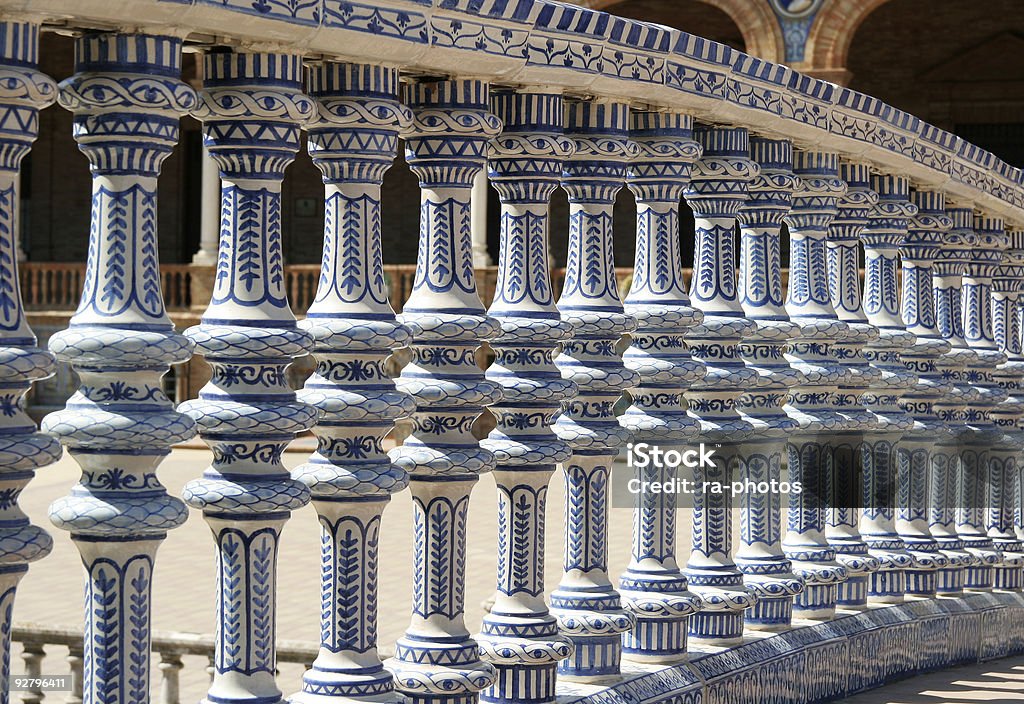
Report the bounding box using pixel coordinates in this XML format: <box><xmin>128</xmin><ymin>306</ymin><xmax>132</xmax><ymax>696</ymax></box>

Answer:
<box><xmin>797</xmin><ymin>0</ymin><xmax>889</xmax><ymax>79</ymax></box>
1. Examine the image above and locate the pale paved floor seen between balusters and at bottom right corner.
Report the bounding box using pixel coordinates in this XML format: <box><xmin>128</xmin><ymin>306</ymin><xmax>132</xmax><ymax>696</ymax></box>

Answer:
<box><xmin>12</xmin><ymin>448</ymin><xmax>1024</xmax><ymax>704</ymax></box>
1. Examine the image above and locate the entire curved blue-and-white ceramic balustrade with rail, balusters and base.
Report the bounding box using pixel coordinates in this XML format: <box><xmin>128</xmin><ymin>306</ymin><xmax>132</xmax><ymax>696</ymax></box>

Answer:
<box><xmin>6</xmin><ymin>0</ymin><xmax>1024</xmax><ymax>704</ymax></box>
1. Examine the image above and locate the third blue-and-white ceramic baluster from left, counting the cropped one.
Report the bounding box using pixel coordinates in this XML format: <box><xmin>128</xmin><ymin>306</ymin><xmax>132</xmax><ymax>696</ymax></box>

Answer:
<box><xmin>180</xmin><ymin>51</ymin><xmax>316</xmax><ymax>704</ymax></box>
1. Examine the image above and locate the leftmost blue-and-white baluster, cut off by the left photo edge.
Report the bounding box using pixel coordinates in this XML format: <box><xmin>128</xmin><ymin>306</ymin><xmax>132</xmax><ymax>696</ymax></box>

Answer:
<box><xmin>0</xmin><ymin>20</ymin><xmax>60</xmax><ymax>704</ymax></box>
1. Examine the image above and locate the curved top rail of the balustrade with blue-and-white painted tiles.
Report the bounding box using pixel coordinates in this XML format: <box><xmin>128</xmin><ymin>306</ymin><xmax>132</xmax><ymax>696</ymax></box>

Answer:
<box><xmin>12</xmin><ymin>0</ymin><xmax>1024</xmax><ymax>222</ymax></box>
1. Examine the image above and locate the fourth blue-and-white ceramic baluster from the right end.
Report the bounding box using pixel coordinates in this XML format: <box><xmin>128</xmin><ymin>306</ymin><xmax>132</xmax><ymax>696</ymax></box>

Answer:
<box><xmin>896</xmin><ymin>190</ymin><xmax>952</xmax><ymax>597</ymax></box>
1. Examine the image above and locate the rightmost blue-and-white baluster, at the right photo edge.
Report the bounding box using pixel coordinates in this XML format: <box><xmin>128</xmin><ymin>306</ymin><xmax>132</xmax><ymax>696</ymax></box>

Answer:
<box><xmin>986</xmin><ymin>224</ymin><xmax>1024</xmax><ymax>590</ymax></box>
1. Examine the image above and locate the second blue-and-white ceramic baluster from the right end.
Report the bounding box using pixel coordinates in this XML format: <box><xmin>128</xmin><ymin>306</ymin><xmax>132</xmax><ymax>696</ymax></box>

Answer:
<box><xmin>956</xmin><ymin>210</ymin><xmax>1008</xmax><ymax>590</ymax></box>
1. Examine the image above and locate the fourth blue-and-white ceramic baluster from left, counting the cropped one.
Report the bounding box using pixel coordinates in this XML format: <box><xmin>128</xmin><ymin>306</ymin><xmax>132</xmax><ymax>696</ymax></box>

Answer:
<box><xmin>290</xmin><ymin>63</ymin><xmax>416</xmax><ymax>704</ymax></box>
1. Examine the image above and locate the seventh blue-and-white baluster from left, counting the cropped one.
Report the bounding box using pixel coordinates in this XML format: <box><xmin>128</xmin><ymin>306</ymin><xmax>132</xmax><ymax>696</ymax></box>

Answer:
<box><xmin>551</xmin><ymin>101</ymin><xmax>640</xmax><ymax>680</ymax></box>
